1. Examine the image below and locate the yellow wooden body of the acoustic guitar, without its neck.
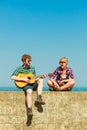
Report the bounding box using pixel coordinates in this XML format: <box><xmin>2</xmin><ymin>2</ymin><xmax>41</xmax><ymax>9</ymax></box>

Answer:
<box><xmin>15</xmin><ymin>73</ymin><xmax>36</xmax><ymax>88</ymax></box>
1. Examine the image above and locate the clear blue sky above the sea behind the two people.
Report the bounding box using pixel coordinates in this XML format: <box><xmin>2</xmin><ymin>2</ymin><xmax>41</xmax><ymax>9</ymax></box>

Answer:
<box><xmin>0</xmin><ymin>0</ymin><xmax>87</xmax><ymax>87</ymax></box>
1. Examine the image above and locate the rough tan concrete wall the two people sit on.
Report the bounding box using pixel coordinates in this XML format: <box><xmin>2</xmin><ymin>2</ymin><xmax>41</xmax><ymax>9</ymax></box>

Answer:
<box><xmin>0</xmin><ymin>92</ymin><xmax>87</xmax><ymax>130</ymax></box>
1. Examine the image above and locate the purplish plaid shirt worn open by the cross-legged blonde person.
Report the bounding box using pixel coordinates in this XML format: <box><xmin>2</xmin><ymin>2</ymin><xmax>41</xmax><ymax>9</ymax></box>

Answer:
<box><xmin>51</xmin><ymin>66</ymin><xmax>74</xmax><ymax>83</ymax></box>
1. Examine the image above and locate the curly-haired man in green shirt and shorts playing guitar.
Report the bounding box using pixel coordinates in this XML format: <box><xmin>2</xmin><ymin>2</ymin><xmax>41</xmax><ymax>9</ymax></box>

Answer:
<box><xmin>11</xmin><ymin>54</ymin><xmax>44</xmax><ymax>125</ymax></box>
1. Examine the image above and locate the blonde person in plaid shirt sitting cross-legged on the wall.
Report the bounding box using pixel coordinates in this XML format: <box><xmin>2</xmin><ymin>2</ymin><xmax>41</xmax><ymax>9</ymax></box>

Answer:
<box><xmin>47</xmin><ymin>57</ymin><xmax>75</xmax><ymax>91</ymax></box>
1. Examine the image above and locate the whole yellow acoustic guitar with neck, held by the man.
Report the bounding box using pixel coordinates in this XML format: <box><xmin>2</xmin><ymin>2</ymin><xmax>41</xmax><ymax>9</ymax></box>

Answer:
<box><xmin>15</xmin><ymin>73</ymin><xmax>50</xmax><ymax>88</ymax></box>
